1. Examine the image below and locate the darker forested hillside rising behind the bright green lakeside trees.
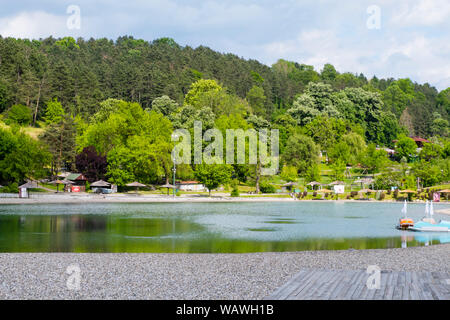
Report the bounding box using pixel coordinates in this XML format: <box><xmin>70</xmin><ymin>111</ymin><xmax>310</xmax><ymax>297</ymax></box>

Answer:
<box><xmin>0</xmin><ymin>37</ymin><xmax>450</xmax><ymax>137</ymax></box>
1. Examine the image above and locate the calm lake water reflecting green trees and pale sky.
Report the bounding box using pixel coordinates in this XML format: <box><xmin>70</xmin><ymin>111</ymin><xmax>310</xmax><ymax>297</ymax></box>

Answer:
<box><xmin>0</xmin><ymin>201</ymin><xmax>450</xmax><ymax>253</ymax></box>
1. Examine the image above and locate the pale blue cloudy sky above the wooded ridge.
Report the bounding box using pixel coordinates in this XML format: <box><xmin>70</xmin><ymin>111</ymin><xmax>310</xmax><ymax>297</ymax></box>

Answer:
<box><xmin>0</xmin><ymin>0</ymin><xmax>450</xmax><ymax>90</ymax></box>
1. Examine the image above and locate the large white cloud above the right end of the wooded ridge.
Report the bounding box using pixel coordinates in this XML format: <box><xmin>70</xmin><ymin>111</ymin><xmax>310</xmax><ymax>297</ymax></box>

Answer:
<box><xmin>264</xmin><ymin>29</ymin><xmax>450</xmax><ymax>89</ymax></box>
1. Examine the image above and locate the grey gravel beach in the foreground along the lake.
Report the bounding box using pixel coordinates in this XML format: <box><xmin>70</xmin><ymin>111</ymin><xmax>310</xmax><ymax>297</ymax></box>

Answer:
<box><xmin>0</xmin><ymin>244</ymin><xmax>450</xmax><ymax>299</ymax></box>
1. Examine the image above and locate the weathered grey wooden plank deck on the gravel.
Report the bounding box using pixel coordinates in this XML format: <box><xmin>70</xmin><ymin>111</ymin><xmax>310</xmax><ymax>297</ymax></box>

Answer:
<box><xmin>265</xmin><ymin>270</ymin><xmax>450</xmax><ymax>300</ymax></box>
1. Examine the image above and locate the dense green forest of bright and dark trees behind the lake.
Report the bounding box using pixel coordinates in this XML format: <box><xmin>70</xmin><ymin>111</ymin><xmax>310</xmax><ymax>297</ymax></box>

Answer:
<box><xmin>0</xmin><ymin>36</ymin><xmax>450</xmax><ymax>190</ymax></box>
